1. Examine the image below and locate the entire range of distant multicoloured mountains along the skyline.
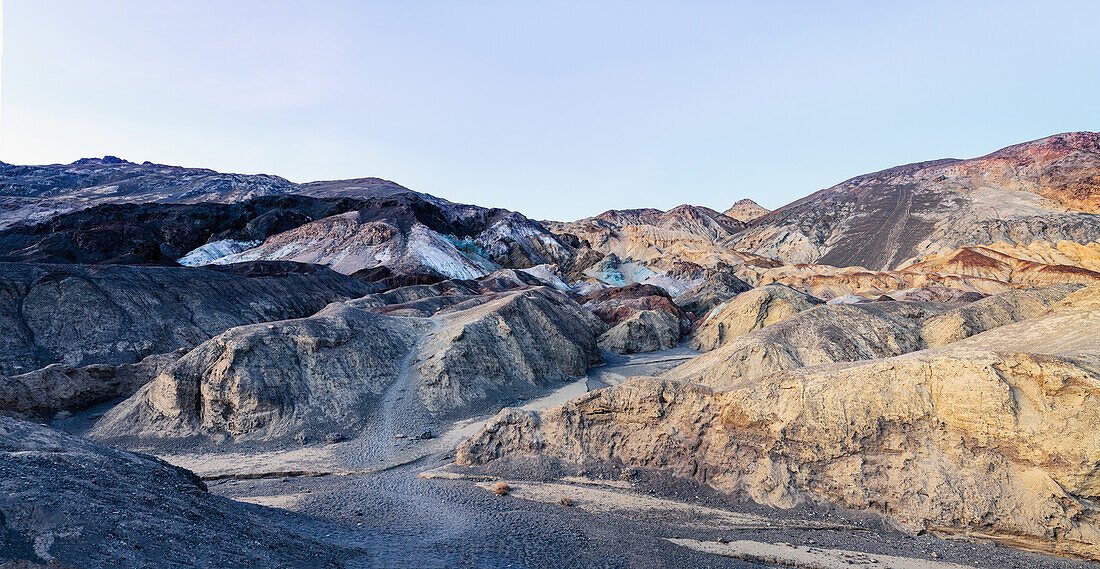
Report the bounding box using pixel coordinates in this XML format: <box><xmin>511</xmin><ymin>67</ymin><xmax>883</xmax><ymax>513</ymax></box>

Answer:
<box><xmin>0</xmin><ymin>132</ymin><xmax>1100</xmax><ymax>298</ymax></box>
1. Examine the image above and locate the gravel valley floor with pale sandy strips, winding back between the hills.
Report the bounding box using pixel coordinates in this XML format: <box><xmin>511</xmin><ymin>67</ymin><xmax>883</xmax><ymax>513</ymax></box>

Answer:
<box><xmin>55</xmin><ymin>348</ymin><xmax>1096</xmax><ymax>569</ymax></box>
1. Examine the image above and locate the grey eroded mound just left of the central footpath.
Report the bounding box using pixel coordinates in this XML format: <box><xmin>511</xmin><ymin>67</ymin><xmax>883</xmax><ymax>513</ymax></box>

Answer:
<box><xmin>91</xmin><ymin>304</ymin><xmax>418</xmax><ymax>437</ymax></box>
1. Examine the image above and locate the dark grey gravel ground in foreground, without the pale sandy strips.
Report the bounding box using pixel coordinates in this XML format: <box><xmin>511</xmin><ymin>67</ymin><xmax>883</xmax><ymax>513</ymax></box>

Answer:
<box><xmin>210</xmin><ymin>457</ymin><xmax>1100</xmax><ymax>569</ymax></box>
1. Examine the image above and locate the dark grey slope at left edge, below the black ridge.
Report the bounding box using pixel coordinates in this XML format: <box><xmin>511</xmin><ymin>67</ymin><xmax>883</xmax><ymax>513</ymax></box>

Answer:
<box><xmin>0</xmin><ymin>263</ymin><xmax>373</xmax><ymax>376</ymax></box>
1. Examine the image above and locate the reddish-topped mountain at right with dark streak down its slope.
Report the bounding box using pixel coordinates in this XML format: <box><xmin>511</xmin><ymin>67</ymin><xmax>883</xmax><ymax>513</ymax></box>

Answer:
<box><xmin>726</xmin><ymin>132</ymin><xmax>1100</xmax><ymax>270</ymax></box>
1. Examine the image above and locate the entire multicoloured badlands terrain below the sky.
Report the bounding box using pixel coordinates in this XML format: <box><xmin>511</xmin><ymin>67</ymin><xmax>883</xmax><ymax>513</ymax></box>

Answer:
<box><xmin>0</xmin><ymin>132</ymin><xmax>1100</xmax><ymax>569</ymax></box>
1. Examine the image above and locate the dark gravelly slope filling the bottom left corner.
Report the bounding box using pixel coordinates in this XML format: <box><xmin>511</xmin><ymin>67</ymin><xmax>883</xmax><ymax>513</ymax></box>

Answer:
<box><xmin>0</xmin><ymin>417</ymin><xmax>349</xmax><ymax>569</ymax></box>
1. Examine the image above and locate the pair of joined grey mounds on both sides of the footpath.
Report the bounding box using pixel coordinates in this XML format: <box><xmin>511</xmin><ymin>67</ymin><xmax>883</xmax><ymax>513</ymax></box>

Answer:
<box><xmin>90</xmin><ymin>287</ymin><xmax>603</xmax><ymax>439</ymax></box>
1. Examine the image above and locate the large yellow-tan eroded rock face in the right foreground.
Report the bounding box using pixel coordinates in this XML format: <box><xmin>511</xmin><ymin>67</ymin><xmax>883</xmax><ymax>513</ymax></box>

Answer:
<box><xmin>459</xmin><ymin>285</ymin><xmax>1100</xmax><ymax>559</ymax></box>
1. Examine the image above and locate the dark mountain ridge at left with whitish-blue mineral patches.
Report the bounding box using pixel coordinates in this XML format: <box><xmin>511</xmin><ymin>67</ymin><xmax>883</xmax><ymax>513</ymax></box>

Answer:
<box><xmin>0</xmin><ymin>158</ymin><xmax>573</xmax><ymax>278</ymax></box>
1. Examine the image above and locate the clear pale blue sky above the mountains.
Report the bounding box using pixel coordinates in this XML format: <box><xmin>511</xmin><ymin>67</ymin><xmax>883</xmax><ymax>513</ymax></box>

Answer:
<box><xmin>0</xmin><ymin>0</ymin><xmax>1100</xmax><ymax>219</ymax></box>
